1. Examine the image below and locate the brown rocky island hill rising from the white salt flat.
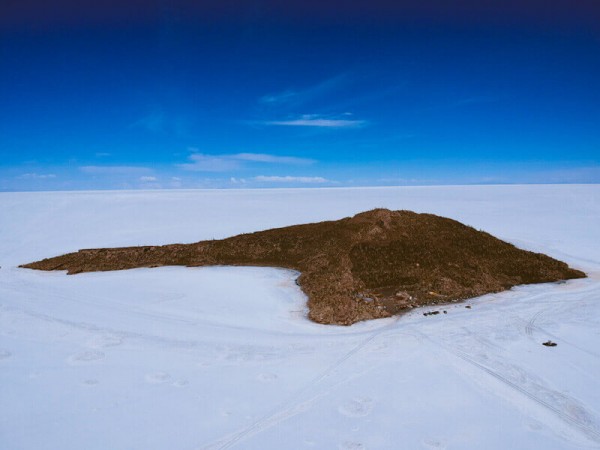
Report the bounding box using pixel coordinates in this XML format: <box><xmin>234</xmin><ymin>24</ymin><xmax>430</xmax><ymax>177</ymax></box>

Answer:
<box><xmin>21</xmin><ymin>209</ymin><xmax>585</xmax><ymax>325</ymax></box>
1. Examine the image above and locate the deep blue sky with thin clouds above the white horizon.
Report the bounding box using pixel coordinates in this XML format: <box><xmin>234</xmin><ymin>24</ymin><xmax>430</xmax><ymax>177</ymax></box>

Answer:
<box><xmin>0</xmin><ymin>0</ymin><xmax>600</xmax><ymax>190</ymax></box>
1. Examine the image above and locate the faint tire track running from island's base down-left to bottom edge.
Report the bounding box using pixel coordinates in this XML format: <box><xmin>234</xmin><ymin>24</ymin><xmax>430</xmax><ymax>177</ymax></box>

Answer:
<box><xmin>201</xmin><ymin>317</ymin><xmax>400</xmax><ymax>450</ymax></box>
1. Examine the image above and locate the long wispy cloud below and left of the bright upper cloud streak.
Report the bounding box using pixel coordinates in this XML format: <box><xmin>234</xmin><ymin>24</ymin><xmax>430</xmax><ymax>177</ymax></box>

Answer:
<box><xmin>177</xmin><ymin>153</ymin><xmax>316</xmax><ymax>172</ymax></box>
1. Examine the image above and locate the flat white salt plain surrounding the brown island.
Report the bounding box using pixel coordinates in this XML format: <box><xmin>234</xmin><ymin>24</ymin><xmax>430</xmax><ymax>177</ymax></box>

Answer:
<box><xmin>0</xmin><ymin>185</ymin><xmax>600</xmax><ymax>450</ymax></box>
